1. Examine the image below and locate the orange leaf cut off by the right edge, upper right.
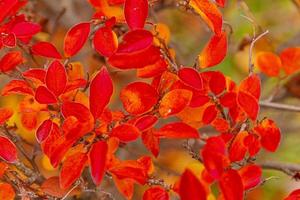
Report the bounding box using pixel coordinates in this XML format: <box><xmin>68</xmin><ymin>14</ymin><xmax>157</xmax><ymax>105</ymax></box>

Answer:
<box><xmin>280</xmin><ymin>47</ymin><xmax>300</xmax><ymax>75</ymax></box>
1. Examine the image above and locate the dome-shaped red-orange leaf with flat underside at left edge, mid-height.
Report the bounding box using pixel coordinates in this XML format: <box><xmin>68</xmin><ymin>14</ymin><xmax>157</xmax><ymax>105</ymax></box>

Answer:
<box><xmin>1</xmin><ymin>80</ymin><xmax>34</xmax><ymax>96</ymax></box>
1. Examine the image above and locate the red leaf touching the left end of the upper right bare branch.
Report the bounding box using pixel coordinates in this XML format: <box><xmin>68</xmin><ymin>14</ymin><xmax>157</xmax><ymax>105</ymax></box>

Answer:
<box><xmin>237</xmin><ymin>92</ymin><xmax>259</xmax><ymax>120</ymax></box>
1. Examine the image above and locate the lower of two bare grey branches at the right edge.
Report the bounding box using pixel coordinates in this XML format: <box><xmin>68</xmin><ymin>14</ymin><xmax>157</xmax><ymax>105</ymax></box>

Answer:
<box><xmin>258</xmin><ymin>161</ymin><xmax>300</xmax><ymax>178</ymax></box>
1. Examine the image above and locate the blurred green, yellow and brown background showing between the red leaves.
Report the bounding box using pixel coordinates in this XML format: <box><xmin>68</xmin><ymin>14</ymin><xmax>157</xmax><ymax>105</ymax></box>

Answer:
<box><xmin>0</xmin><ymin>0</ymin><xmax>300</xmax><ymax>200</ymax></box>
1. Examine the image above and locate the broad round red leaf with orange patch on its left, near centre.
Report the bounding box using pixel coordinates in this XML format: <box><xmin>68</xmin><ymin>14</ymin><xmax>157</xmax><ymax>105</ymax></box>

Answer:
<box><xmin>120</xmin><ymin>82</ymin><xmax>158</xmax><ymax>115</ymax></box>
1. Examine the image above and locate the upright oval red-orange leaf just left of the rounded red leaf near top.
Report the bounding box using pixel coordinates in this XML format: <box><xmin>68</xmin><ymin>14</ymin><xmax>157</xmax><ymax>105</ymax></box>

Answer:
<box><xmin>64</xmin><ymin>22</ymin><xmax>91</xmax><ymax>57</ymax></box>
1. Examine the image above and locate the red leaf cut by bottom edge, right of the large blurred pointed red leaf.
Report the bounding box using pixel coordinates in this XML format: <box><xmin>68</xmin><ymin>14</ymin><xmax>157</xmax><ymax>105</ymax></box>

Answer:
<box><xmin>219</xmin><ymin>169</ymin><xmax>244</xmax><ymax>200</ymax></box>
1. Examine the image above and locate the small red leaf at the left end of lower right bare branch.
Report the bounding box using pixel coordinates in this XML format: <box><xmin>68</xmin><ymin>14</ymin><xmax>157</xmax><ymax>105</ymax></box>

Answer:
<box><xmin>238</xmin><ymin>164</ymin><xmax>262</xmax><ymax>190</ymax></box>
